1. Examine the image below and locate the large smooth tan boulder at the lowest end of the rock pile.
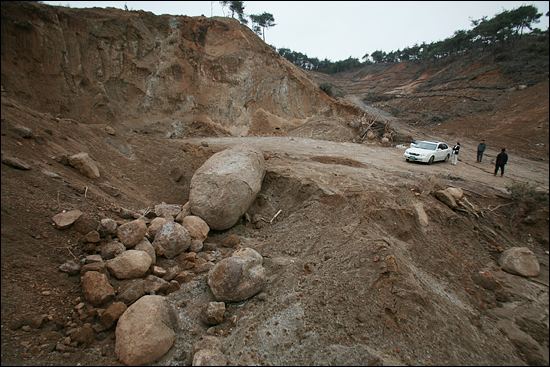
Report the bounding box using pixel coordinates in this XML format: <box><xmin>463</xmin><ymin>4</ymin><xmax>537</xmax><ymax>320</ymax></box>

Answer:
<box><xmin>115</xmin><ymin>296</ymin><xmax>179</xmax><ymax>366</ymax></box>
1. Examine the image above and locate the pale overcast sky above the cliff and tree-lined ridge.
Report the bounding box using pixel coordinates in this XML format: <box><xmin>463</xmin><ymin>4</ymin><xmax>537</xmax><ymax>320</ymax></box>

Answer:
<box><xmin>43</xmin><ymin>1</ymin><xmax>549</xmax><ymax>62</ymax></box>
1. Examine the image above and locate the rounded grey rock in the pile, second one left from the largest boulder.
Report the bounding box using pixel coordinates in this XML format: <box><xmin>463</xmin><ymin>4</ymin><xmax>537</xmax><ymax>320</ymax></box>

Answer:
<box><xmin>153</xmin><ymin>222</ymin><xmax>191</xmax><ymax>259</ymax></box>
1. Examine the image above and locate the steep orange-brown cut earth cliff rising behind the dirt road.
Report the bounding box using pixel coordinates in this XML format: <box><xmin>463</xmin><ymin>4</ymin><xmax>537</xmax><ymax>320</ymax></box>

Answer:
<box><xmin>2</xmin><ymin>2</ymin><xmax>358</xmax><ymax>136</ymax></box>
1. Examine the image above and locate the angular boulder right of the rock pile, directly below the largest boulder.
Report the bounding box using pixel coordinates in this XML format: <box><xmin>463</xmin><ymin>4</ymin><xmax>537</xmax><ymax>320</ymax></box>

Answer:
<box><xmin>207</xmin><ymin>248</ymin><xmax>267</xmax><ymax>302</ymax></box>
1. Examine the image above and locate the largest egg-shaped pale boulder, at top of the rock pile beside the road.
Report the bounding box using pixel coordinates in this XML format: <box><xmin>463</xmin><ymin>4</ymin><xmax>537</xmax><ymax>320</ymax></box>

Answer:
<box><xmin>189</xmin><ymin>145</ymin><xmax>265</xmax><ymax>231</ymax></box>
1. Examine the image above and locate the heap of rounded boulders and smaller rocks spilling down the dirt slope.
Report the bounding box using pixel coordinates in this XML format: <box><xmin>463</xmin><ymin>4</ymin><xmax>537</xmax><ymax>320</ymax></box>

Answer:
<box><xmin>52</xmin><ymin>146</ymin><xmax>266</xmax><ymax>365</ymax></box>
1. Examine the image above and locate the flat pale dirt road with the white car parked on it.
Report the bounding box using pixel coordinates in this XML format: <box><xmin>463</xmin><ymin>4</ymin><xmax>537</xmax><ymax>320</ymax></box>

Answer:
<box><xmin>183</xmin><ymin>137</ymin><xmax>548</xmax><ymax>198</ymax></box>
